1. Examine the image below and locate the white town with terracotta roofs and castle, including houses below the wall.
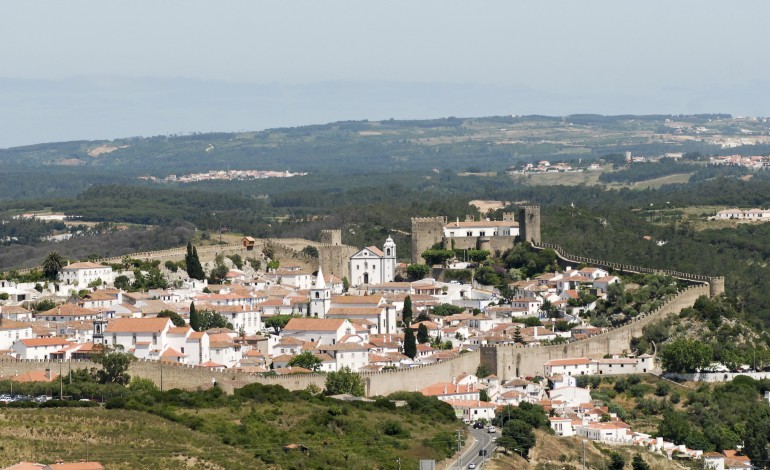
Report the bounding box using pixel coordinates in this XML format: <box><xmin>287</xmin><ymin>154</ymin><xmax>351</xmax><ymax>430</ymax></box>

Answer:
<box><xmin>0</xmin><ymin>206</ymin><xmax>729</xmax><ymax>470</ymax></box>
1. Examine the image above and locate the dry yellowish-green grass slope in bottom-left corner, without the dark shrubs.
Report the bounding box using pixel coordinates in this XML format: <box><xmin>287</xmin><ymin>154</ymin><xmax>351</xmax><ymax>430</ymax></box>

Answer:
<box><xmin>0</xmin><ymin>408</ymin><xmax>260</xmax><ymax>470</ymax></box>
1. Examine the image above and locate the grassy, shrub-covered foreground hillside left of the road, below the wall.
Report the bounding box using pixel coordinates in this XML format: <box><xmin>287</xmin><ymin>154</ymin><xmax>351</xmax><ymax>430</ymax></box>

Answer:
<box><xmin>0</xmin><ymin>387</ymin><xmax>462</xmax><ymax>470</ymax></box>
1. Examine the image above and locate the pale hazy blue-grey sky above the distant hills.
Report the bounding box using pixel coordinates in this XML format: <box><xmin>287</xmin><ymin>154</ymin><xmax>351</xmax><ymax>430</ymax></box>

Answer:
<box><xmin>0</xmin><ymin>0</ymin><xmax>770</xmax><ymax>148</ymax></box>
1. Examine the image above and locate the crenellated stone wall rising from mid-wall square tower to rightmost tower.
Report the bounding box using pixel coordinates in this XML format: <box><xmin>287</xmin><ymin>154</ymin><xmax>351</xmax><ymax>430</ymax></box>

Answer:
<box><xmin>480</xmin><ymin>284</ymin><xmax>709</xmax><ymax>380</ymax></box>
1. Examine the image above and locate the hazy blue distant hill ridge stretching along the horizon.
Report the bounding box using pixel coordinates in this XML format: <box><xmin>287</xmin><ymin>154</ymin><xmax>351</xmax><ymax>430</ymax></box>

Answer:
<box><xmin>0</xmin><ymin>114</ymin><xmax>756</xmax><ymax>198</ymax></box>
